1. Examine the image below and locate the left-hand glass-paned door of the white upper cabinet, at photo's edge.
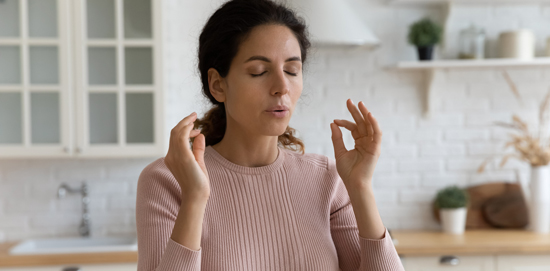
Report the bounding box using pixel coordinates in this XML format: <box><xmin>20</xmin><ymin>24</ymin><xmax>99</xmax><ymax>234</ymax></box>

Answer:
<box><xmin>0</xmin><ymin>0</ymin><xmax>71</xmax><ymax>157</ymax></box>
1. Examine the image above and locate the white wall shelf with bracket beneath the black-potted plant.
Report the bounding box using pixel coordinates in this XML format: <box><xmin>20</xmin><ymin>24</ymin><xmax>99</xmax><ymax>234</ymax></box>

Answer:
<box><xmin>394</xmin><ymin>57</ymin><xmax>550</xmax><ymax>118</ymax></box>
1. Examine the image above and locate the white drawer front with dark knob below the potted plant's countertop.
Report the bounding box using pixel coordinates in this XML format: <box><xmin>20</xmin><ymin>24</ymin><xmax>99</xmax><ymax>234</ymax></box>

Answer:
<box><xmin>403</xmin><ymin>255</ymin><xmax>497</xmax><ymax>271</ymax></box>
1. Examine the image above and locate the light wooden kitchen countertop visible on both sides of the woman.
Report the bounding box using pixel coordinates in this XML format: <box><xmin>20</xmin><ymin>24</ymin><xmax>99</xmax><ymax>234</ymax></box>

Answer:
<box><xmin>4</xmin><ymin>232</ymin><xmax>550</xmax><ymax>267</ymax></box>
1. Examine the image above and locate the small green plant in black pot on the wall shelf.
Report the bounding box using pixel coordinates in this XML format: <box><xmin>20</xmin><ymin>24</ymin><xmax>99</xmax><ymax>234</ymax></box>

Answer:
<box><xmin>408</xmin><ymin>18</ymin><xmax>442</xmax><ymax>60</ymax></box>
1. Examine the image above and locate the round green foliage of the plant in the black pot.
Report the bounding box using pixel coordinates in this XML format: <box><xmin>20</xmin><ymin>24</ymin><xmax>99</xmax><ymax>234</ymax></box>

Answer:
<box><xmin>408</xmin><ymin>18</ymin><xmax>443</xmax><ymax>47</ymax></box>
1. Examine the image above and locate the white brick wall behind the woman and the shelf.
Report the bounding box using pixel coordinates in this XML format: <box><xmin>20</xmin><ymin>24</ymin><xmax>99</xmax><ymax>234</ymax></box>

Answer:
<box><xmin>0</xmin><ymin>0</ymin><xmax>550</xmax><ymax>241</ymax></box>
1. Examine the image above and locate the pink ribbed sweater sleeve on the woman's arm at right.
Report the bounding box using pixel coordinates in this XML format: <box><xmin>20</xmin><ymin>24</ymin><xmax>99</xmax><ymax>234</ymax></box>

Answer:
<box><xmin>328</xmin><ymin>158</ymin><xmax>405</xmax><ymax>271</ymax></box>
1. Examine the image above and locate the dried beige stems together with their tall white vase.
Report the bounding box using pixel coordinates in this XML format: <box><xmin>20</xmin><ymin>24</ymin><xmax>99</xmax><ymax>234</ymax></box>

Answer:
<box><xmin>478</xmin><ymin>72</ymin><xmax>550</xmax><ymax>234</ymax></box>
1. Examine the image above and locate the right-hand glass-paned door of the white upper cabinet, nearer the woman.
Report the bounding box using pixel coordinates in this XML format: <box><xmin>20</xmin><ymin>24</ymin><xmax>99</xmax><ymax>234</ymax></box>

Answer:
<box><xmin>76</xmin><ymin>0</ymin><xmax>163</xmax><ymax>157</ymax></box>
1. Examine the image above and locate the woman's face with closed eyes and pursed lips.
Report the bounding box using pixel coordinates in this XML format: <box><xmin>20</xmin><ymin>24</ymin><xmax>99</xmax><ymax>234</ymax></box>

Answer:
<box><xmin>220</xmin><ymin>25</ymin><xmax>303</xmax><ymax>136</ymax></box>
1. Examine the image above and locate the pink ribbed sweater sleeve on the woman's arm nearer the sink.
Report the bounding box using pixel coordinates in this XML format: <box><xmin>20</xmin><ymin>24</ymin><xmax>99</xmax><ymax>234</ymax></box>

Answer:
<box><xmin>136</xmin><ymin>158</ymin><xmax>202</xmax><ymax>271</ymax></box>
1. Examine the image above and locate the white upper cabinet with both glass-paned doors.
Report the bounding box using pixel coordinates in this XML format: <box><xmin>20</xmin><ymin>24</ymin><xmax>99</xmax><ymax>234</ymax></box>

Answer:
<box><xmin>0</xmin><ymin>0</ymin><xmax>164</xmax><ymax>158</ymax></box>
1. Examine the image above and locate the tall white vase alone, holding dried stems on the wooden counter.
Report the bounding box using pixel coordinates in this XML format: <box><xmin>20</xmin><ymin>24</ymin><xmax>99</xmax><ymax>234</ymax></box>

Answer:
<box><xmin>529</xmin><ymin>165</ymin><xmax>550</xmax><ymax>234</ymax></box>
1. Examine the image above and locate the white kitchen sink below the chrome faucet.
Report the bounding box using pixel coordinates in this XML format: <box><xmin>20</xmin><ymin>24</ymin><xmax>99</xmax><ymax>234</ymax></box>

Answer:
<box><xmin>9</xmin><ymin>237</ymin><xmax>137</xmax><ymax>255</ymax></box>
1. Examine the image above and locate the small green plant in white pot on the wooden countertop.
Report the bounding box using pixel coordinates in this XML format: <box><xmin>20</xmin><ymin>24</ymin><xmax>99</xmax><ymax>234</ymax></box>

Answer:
<box><xmin>435</xmin><ymin>185</ymin><xmax>469</xmax><ymax>234</ymax></box>
